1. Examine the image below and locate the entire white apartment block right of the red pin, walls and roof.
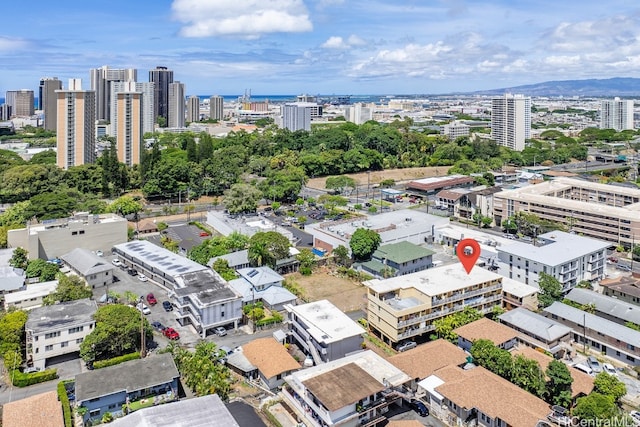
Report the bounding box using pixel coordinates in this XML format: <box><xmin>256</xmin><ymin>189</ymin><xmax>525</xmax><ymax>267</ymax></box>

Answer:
<box><xmin>496</xmin><ymin>230</ymin><xmax>611</xmax><ymax>292</ymax></box>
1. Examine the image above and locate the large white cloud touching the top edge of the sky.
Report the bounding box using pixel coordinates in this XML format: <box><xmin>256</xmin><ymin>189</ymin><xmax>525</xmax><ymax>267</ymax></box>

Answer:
<box><xmin>171</xmin><ymin>0</ymin><xmax>313</xmax><ymax>38</ymax></box>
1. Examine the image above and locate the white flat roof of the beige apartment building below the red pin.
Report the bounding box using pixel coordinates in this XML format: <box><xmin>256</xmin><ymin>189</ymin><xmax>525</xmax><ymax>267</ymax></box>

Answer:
<box><xmin>365</xmin><ymin>263</ymin><xmax>504</xmax><ymax>296</ymax></box>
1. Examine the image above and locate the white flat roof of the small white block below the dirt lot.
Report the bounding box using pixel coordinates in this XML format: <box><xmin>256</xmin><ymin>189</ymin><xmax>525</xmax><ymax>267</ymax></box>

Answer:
<box><xmin>286</xmin><ymin>300</ymin><xmax>364</xmax><ymax>343</ymax></box>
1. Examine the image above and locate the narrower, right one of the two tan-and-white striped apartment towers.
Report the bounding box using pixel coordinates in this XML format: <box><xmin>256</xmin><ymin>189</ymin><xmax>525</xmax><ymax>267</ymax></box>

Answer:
<box><xmin>112</xmin><ymin>82</ymin><xmax>144</xmax><ymax>166</ymax></box>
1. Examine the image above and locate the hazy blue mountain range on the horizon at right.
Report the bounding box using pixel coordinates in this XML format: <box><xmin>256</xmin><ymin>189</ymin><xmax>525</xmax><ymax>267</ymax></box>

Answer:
<box><xmin>470</xmin><ymin>77</ymin><xmax>640</xmax><ymax>97</ymax></box>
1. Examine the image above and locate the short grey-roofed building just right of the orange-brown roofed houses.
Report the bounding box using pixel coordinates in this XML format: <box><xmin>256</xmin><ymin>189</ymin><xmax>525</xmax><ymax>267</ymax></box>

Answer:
<box><xmin>498</xmin><ymin>307</ymin><xmax>571</xmax><ymax>357</ymax></box>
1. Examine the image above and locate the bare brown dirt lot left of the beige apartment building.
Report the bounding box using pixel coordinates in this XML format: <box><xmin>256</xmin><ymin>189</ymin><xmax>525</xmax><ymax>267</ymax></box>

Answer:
<box><xmin>288</xmin><ymin>269</ymin><xmax>367</xmax><ymax>313</ymax></box>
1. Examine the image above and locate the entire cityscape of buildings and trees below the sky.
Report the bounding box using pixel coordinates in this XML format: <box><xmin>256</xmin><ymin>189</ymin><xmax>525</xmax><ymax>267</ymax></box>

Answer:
<box><xmin>0</xmin><ymin>80</ymin><xmax>640</xmax><ymax>427</ymax></box>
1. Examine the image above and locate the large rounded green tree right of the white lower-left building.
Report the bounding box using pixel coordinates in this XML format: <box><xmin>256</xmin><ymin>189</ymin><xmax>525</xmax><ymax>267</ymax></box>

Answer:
<box><xmin>80</xmin><ymin>304</ymin><xmax>153</xmax><ymax>361</ymax></box>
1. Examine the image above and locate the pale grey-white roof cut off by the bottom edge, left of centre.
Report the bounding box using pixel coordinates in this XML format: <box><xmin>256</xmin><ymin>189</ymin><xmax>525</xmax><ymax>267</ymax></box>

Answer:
<box><xmin>110</xmin><ymin>394</ymin><xmax>240</xmax><ymax>427</ymax></box>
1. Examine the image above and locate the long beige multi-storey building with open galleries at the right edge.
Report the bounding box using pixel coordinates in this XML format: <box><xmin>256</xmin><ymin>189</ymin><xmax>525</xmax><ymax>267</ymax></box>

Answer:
<box><xmin>493</xmin><ymin>177</ymin><xmax>640</xmax><ymax>247</ymax></box>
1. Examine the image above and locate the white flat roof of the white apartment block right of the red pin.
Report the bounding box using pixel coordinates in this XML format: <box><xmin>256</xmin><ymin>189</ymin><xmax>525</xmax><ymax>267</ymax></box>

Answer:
<box><xmin>498</xmin><ymin>231</ymin><xmax>611</xmax><ymax>266</ymax></box>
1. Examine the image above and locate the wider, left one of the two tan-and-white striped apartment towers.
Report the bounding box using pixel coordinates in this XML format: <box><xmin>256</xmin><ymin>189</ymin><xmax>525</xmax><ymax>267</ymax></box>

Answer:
<box><xmin>56</xmin><ymin>79</ymin><xmax>96</xmax><ymax>169</ymax></box>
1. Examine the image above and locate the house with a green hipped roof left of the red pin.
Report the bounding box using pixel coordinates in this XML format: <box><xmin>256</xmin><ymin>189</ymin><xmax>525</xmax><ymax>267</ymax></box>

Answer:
<box><xmin>361</xmin><ymin>242</ymin><xmax>435</xmax><ymax>278</ymax></box>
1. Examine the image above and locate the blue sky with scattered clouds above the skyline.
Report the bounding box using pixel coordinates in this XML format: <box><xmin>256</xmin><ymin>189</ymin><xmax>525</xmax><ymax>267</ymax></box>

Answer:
<box><xmin>0</xmin><ymin>0</ymin><xmax>640</xmax><ymax>97</ymax></box>
